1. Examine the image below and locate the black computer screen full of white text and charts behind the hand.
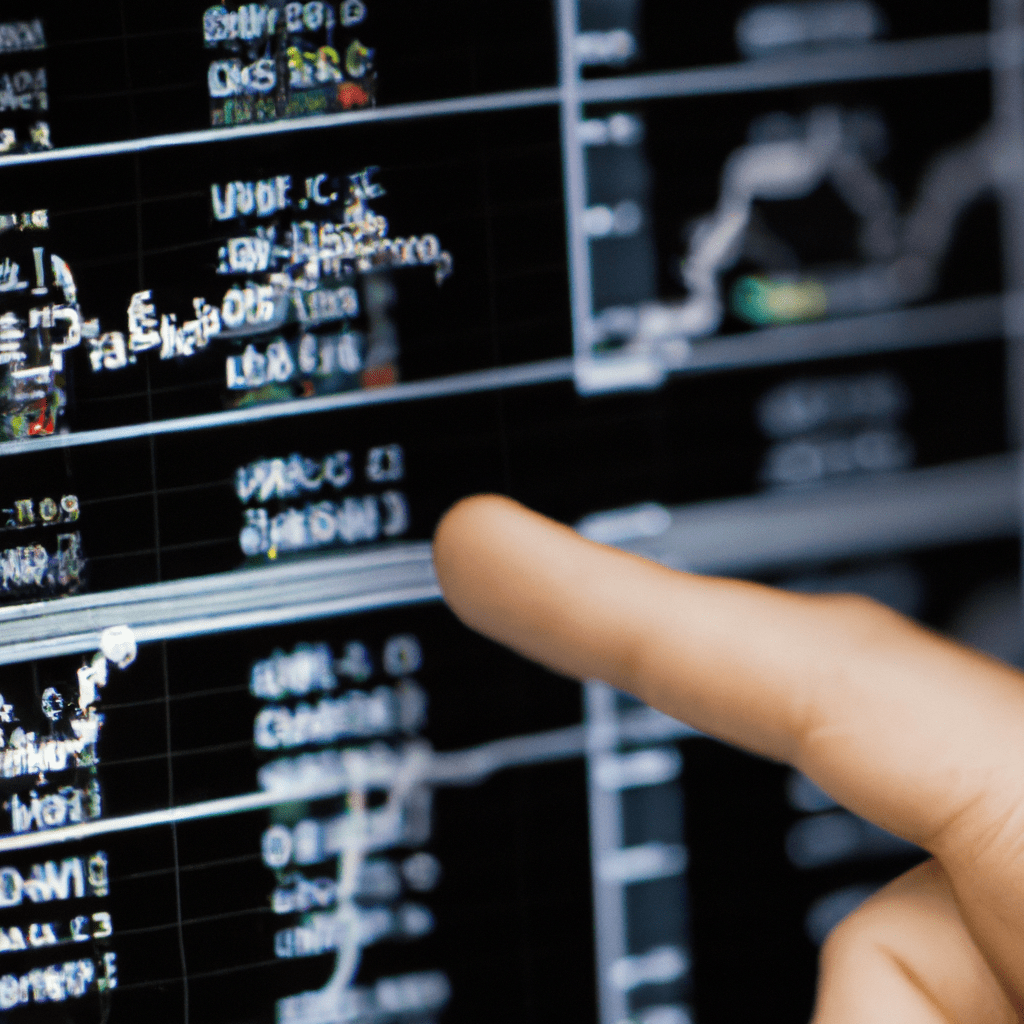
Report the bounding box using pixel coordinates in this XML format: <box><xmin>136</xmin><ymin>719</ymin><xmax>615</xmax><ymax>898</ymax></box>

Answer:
<box><xmin>0</xmin><ymin>6</ymin><xmax>1024</xmax><ymax>1024</ymax></box>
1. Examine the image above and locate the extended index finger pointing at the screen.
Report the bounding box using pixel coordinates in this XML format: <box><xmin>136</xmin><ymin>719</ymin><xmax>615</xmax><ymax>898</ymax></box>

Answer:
<box><xmin>434</xmin><ymin>496</ymin><xmax>1024</xmax><ymax>850</ymax></box>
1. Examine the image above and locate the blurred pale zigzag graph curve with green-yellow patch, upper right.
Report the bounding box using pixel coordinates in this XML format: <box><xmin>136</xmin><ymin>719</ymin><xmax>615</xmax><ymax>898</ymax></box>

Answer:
<box><xmin>632</xmin><ymin>106</ymin><xmax>998</xmax><ymax>346</ymax></box>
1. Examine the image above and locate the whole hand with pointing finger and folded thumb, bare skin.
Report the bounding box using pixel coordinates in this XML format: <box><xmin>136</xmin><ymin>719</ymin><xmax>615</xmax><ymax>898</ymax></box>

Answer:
<box><xmin>434</xmin><ymin>496</ymin><xmax>1024</xmax><ymax>1024</ymax></box>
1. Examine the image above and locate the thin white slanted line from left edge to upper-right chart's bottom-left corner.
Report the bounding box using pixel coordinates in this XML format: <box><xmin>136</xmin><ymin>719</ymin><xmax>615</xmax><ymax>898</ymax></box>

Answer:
<box><xmin>0</xmin><ymin>356</ymin><xmax>572</xmax><ymax>458</ymax></box>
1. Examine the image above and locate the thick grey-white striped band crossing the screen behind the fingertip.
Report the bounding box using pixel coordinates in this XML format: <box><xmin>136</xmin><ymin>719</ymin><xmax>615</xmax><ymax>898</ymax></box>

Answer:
<box><xmin>0</xmin><ymin>455</ymin><xmax>1020</xmax><ymax>663</ymax></box>
